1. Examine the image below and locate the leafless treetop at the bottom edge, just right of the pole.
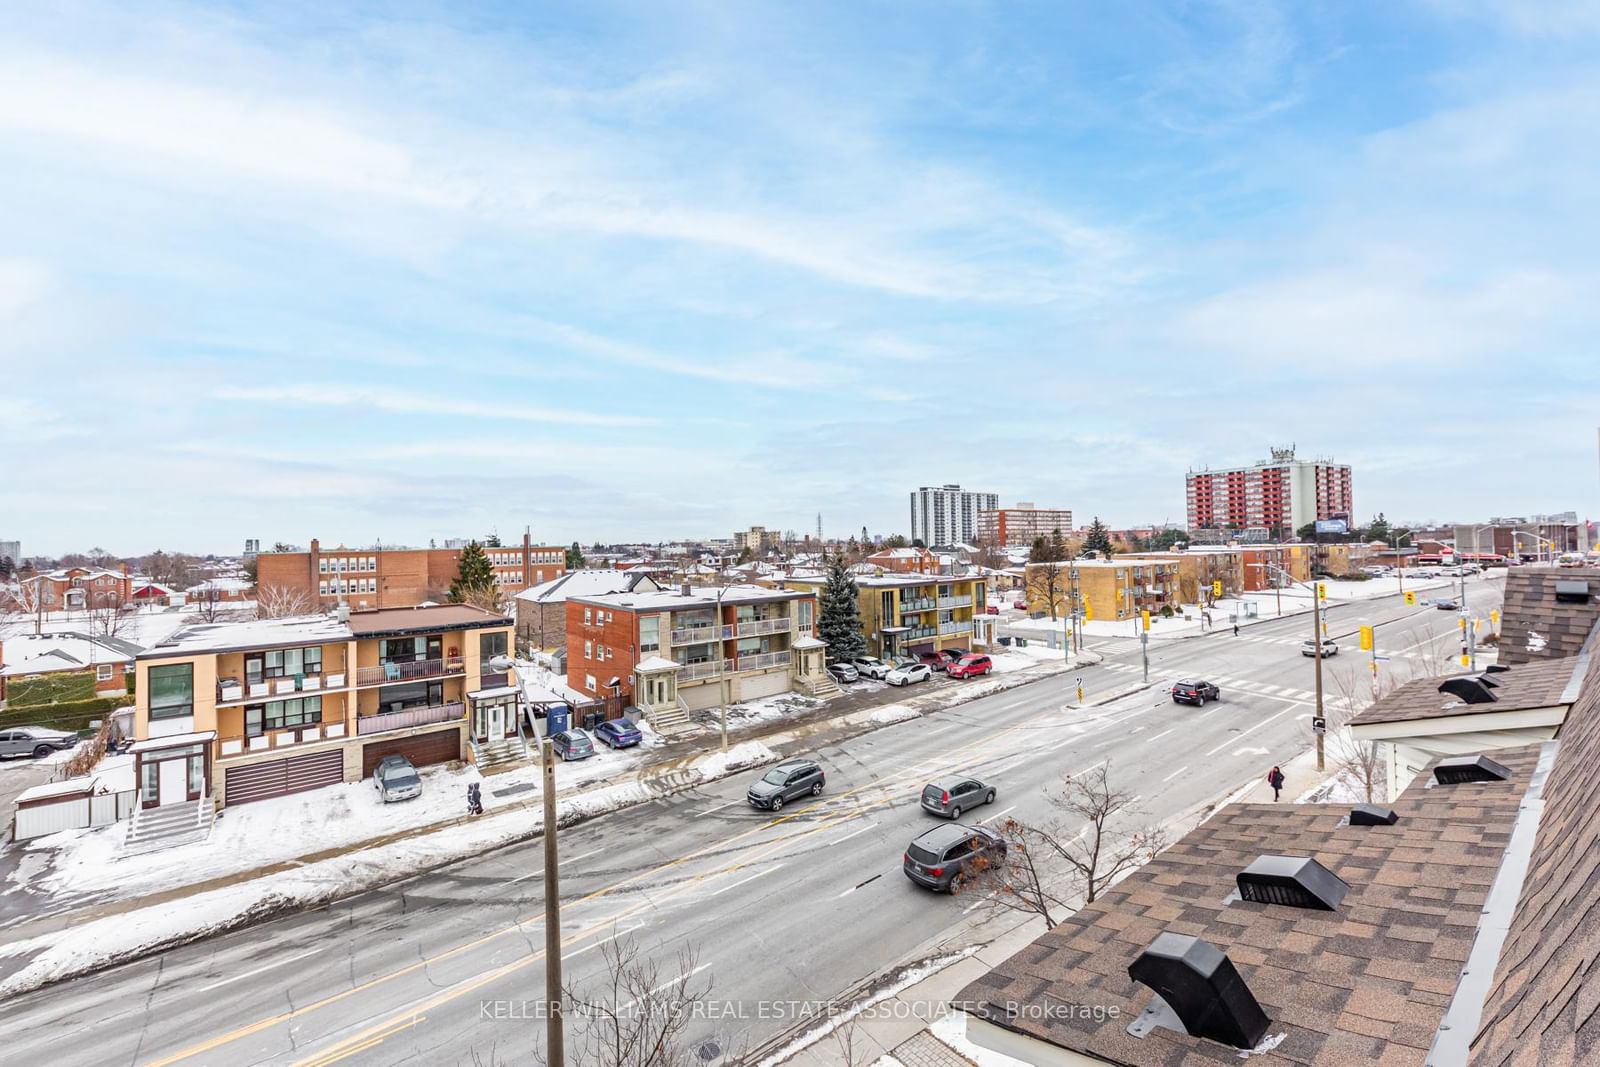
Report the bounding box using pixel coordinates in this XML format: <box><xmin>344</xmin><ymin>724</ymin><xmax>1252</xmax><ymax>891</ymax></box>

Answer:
<box><xmin>533</xmin><ymin>936</ymin><xmax>738</xmax><ymax>1067</ymax></box>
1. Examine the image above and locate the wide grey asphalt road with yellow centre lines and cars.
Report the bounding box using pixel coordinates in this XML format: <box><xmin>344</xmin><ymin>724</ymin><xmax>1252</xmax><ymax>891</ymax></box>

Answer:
<box><xmin>0</xmin><ymin>579</ymin><xmax>1501</xmax><ymax>1064</ymax></box>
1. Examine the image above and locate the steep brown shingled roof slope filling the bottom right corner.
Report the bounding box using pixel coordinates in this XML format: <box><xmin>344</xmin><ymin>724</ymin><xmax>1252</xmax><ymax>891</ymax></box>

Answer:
<box><xmin>1472</xmin><ymin>646</ymin><xmax>1600</xmax><ymax>1067</ymax></box>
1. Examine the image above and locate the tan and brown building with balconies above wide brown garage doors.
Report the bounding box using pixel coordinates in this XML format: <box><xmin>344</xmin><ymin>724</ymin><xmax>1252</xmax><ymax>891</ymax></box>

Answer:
<box><xmin>133</xmin><ymin>605</ymin><xmax>522</xmax><ymax>809</ymax></box>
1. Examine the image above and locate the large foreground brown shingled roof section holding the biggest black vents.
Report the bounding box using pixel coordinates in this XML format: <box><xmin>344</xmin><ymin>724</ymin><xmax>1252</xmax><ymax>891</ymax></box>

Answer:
<box><xmin>955</xmin><ymin>745</ymin><xmax>1542</xmax><ymax>1067</ymax></box>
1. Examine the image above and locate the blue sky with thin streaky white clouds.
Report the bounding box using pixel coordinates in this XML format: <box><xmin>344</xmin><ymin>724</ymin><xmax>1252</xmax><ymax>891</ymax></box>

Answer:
<box><xmin>0</xmin><ymin>0</ymin><xmax>1600</xmax><ymax>553</ymax></box>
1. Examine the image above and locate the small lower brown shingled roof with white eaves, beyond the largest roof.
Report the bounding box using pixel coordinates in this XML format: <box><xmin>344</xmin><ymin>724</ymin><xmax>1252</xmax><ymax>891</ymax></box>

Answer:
<box><xmin>1350</xmin><ymin>656</ymin><xmax>1589</xmax><ymax>725</ymax></box>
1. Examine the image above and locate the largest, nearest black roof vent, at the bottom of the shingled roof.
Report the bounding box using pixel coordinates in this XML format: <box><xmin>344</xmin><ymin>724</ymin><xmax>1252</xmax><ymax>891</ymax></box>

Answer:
<box><xmin>1128</xmin><ymin>933</ymin><xmax>1270</xmax><ymax>1048</ymax></box>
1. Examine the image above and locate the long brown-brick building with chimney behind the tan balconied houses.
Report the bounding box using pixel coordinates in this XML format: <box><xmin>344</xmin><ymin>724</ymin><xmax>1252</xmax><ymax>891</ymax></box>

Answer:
<box><xmin>256</xmin><ymin>534</ymin><xmax>566</xmax><ymax>609</ymax></box>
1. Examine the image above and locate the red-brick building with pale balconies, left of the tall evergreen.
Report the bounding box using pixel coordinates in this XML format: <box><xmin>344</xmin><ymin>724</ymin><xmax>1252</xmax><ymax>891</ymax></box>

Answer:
<box><xmin>566</xmin><ymin>584</ymin><xmax>829</xmax><ymax>728</ymax></box>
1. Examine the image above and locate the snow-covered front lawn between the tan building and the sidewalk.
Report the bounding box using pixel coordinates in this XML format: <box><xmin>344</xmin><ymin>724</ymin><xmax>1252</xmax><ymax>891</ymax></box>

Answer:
<box><xmin>26</xmin><ymin>744</ymin><xmax>652</xmax><ymax>896</ymax></box>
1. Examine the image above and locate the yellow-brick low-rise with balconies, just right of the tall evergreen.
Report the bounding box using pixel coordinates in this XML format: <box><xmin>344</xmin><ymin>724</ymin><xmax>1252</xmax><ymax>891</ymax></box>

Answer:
<box><xmin>789</xmin><ymin>574</ymin><xmax>994</xmax><ymax>659</ymax></box>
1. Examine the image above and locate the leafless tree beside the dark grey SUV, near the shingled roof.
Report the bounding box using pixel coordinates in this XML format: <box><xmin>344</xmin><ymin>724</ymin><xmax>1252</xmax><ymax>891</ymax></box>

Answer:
<box><xmin>960</xmin><ymin>761</ymin><xmax>1166</xmax><ymax>928</ymax></box>
